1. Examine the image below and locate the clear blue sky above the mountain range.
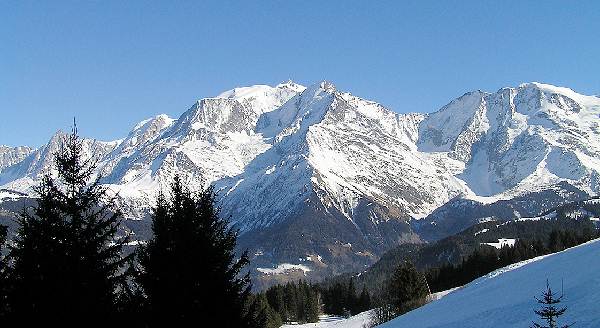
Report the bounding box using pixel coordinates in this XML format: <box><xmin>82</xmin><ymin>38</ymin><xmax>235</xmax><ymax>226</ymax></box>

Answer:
<box><xmin>0</xmin><ymin>1</ymin><xmax>600</xmax><ymax>146</ymax></box>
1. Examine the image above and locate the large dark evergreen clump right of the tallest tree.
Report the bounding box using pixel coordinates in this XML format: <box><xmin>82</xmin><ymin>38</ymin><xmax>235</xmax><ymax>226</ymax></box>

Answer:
<box><xmin>138</xmin><ymin>177</ymin><xmax>251</xmax><ymax>327</ymax></box>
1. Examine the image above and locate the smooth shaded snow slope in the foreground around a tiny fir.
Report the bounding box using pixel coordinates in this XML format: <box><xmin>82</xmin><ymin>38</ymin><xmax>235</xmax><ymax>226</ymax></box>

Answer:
<box><xmin>380</xmin><ymin>239</ymin><xmax>600</xmax><ymax>328</ymax></box>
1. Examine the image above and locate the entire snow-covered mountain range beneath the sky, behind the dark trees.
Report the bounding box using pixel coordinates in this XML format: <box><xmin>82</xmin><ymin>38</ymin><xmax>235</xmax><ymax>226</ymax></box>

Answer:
<box><xmin>0</xmin><ymin>81</ymin><xmax>600</xmax><ymax>282</ymax></box>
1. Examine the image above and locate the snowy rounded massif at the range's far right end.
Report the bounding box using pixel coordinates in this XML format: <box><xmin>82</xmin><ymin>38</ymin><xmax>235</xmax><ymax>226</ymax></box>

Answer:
<box><xmin>418</xmin><ymin>83</ymin><xmax>600</xmax><ymax>197</ymax></box>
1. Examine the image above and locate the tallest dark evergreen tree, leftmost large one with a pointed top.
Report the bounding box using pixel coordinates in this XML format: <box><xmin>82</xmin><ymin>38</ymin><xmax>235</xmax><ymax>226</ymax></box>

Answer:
<box><xmin>9</xmin><ymin>127</ymin><xmax>127</xmax><ymax>326</ymax></box>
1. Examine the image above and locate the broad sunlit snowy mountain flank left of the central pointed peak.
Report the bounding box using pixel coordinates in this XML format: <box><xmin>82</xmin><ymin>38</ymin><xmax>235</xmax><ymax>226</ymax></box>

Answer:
<box><xmin>97</xmin><ymin>82</ymin><xmax>304</xmax><ymax>217</ymax></box>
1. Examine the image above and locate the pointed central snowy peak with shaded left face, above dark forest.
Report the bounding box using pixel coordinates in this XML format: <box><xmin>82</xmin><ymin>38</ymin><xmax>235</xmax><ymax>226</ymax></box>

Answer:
<box><xmin>217</xmin><ymin>82</ymin><xmax>464</xmax><ymax>231</ymax></box>
